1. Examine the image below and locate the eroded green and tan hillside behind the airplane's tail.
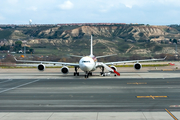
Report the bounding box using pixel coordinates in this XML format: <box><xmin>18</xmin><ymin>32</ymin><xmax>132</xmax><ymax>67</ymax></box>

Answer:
<box><xmin>0</xmin><ymin>24</ymin><xmax>180</xmax><ymax>57</ymax></box>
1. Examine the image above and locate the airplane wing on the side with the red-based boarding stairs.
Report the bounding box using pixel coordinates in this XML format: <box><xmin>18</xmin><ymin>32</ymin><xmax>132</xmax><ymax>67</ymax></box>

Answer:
<box><xmin>105</xmin><ymin>56</ymin><xmax>167</xmax><ymax>65</ymax></box>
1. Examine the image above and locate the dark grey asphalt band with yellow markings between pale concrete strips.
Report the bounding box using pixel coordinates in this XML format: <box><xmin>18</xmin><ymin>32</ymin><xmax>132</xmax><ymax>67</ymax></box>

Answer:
<box><xmin>0</xmin><ymin>76</ymin><xmax>180</xmax><ymax>112</ymax></box>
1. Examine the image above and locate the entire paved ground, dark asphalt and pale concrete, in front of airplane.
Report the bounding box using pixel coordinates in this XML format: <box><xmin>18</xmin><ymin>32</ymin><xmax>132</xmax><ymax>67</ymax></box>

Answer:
<box><xmin>0</xmin><ymin>69</ymin><xmax>180</xmax><ymax>120</ymax></box>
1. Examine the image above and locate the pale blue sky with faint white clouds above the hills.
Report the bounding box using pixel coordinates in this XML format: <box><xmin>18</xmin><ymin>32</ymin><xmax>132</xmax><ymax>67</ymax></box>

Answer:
<box><xmin>0</xmin><ymin>0</ymin><xmax>180</xmax><ymax>25</ymax></box>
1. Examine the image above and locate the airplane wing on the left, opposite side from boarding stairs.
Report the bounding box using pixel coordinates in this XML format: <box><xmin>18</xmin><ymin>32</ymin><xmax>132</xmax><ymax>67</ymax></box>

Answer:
<box><xmin>14</xmin><ymin>57</ymin><xmax>79</xmax><ymax>67</ymax></box>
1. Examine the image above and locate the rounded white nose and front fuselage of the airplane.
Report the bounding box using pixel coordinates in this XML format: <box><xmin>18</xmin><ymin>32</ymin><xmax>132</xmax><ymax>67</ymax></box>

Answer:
<box><xmin>79</xmin><ymin>56</ymin><xmax>97</xmax><ymax>72</ymax></box>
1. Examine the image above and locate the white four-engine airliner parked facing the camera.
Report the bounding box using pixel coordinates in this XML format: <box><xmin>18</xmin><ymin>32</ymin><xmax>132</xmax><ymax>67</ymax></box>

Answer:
<box><xmin>14</xmin><ymin>35</ymin><xmax>166</xmax><ymax>78</ymax></box>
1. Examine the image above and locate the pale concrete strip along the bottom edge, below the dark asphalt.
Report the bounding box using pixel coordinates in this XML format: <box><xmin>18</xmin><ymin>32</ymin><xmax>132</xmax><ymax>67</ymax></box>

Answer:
<box><xmin>0</xmin><ymin>112</ymin><xmax>180</xmax><ymax>120</ymax></box>
